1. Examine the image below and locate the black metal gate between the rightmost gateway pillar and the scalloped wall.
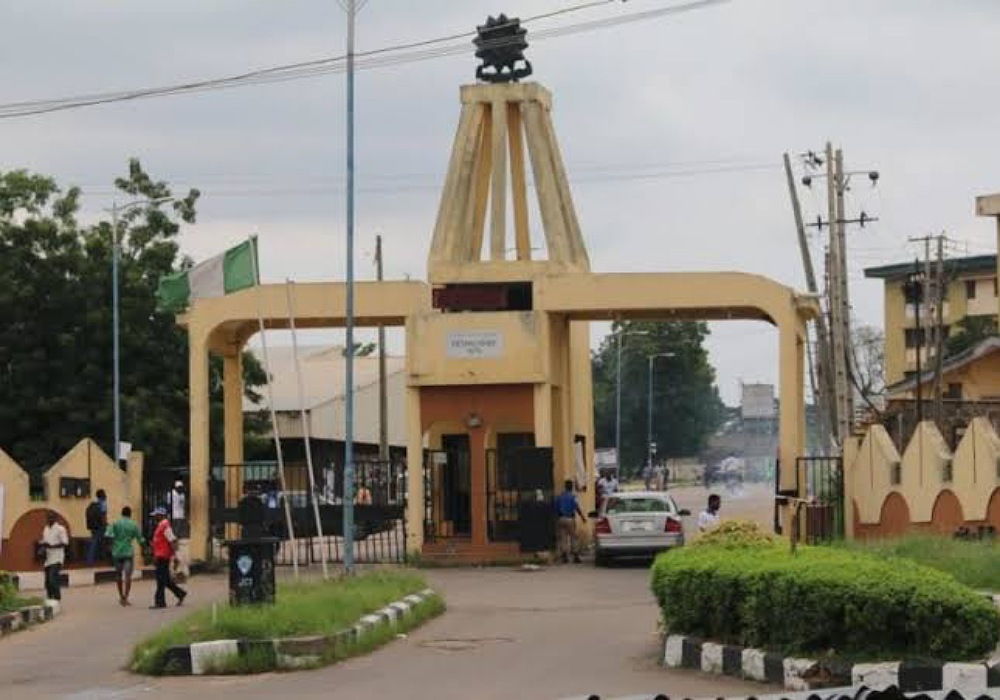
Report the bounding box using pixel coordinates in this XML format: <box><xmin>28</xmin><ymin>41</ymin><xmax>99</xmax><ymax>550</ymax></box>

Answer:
<box><xmin>795</xmin><ymin>457</ymin><xmax>845</xmax><ymax>544</ymax></box>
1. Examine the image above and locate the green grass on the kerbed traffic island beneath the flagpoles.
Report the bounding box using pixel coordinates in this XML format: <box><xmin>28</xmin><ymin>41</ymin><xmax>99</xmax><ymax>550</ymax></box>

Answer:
<box><xmin>129</xmin><ymin>571</ymin><xmax>443</xmax><ymax>674</ymax></box>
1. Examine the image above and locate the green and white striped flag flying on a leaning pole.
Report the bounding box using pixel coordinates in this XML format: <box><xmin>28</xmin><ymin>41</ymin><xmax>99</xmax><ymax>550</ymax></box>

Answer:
<box><xmin>156</xmin><ymin>237</ymin><xmax>260</xmax><ymax>313</ymax></box>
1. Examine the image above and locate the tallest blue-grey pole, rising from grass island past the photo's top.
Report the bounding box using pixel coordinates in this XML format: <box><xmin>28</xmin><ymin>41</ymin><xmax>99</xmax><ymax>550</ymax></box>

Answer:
<box><xmin>344</xmin><ymin>0</ymin><xmax>358</xmax><ymax>575</ymax></box>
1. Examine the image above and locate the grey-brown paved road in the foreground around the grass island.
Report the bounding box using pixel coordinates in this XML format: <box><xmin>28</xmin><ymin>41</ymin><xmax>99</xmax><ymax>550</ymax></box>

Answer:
<box><xmin>0</xmin><ymin>565</ymin><xmax>766</xmax><ymax>700</ymax></box>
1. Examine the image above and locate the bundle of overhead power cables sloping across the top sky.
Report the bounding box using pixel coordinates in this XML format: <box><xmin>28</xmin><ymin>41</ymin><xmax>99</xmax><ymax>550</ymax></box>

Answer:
<box><xmin>0</xmin><ymin>0</ymin><xmax>732</xmax><ymax>119</ymax></box>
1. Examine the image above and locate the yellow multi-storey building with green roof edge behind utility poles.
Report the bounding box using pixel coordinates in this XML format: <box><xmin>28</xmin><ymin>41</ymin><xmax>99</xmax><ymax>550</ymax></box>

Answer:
<box><xmin>865</xmin><ymin>255</ymin><xmax>997</xmax><ymax>394</ymax></box>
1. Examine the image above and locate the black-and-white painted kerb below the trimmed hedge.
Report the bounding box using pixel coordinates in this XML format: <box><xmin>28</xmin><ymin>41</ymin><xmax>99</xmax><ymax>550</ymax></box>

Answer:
<box><xmin>663</xmin><ymin>634</ymin><xmax>1000</xmax><ymax>692</ymax></box>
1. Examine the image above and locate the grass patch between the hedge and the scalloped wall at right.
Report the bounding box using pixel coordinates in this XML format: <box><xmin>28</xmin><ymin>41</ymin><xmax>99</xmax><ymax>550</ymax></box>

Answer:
<box><xmin>844</xmin><ymin>535</ymin><xmax>1000</xmax><ymax>592</ymax></box>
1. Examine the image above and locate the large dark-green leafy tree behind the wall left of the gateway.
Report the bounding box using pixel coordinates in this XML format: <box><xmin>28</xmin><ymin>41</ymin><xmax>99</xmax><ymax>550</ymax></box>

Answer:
<box><xmin>0</xmin><ymin>160</ymin><xmax>262</xmax><ymax>471</ymax></box>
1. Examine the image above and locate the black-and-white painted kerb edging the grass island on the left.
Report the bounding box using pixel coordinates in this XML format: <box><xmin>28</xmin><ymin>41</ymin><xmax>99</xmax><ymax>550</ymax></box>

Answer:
<box><xmin>166</xmin><ymin>588</ymin><xmax>436</xmax><ymax>676</ymax></box>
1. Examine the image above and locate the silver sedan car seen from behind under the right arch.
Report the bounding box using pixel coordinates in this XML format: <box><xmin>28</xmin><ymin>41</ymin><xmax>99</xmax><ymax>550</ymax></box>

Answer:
<box><xmin>594</xmin><ymin>491</ymin><xmax>691</xmax><ymax>566</ymax></box>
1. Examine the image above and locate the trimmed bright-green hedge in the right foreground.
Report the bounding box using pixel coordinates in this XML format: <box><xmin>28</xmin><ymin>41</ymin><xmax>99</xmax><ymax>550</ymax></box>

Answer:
<box><xmin>652</xmin><ymin>545</ymin><xmax>1000</xmax><ymax>661</ymax></box>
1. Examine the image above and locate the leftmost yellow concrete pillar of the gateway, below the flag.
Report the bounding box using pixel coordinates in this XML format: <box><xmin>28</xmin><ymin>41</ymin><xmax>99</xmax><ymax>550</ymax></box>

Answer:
<box><xmin>188</xmin><ymin>328</ymin><xmax>211</xmax><ymax>560</ymax></box>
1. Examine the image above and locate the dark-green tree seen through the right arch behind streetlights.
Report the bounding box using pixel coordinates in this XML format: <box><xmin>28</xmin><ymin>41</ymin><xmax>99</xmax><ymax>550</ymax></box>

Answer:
<box><xmin>591</xmin><ymin>321</ymin><xmax>725</xmax><ymax>472</ymax></box>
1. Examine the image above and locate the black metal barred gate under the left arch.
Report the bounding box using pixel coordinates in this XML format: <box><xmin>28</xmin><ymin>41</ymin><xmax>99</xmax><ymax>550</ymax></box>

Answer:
<box><xmin>209</xmin><ymin>460</ymin><xmax>407</xmax><ymax>565</ymax></box>
